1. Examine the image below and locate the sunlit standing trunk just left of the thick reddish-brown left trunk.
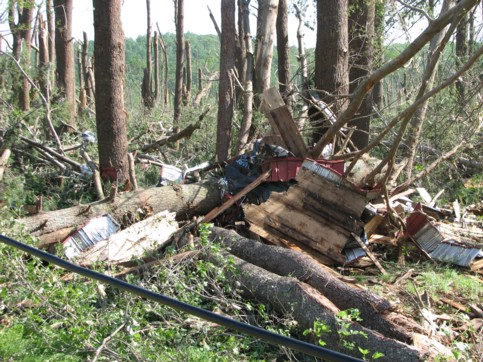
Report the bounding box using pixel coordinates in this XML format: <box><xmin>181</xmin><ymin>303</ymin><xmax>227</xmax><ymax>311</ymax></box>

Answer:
<box><xmin>54</xmin><ymin>0</ymin><xmax>76</xmax><ymax>126</ymax></box>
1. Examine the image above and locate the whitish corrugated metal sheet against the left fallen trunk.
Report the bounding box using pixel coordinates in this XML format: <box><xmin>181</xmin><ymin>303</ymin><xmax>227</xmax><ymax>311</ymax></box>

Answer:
<box><xmin>64</xmin><ymin>215</ymin><xmax>120</xmax><ymax>259</ymax></box>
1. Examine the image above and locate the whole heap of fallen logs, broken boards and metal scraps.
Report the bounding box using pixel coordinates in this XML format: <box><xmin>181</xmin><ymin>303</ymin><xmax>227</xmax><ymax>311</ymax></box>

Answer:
<box><xmin>14</xmin><ymin>90</ymin><xmax>483</xmax><ymax>360</ymax></box>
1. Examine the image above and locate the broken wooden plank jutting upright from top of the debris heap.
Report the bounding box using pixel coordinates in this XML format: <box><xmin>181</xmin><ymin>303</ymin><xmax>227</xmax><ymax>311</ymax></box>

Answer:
<box><xmin>263</xmin><ymin>87</ymin><xmax>308</xmax><ymax>157</ymax></box>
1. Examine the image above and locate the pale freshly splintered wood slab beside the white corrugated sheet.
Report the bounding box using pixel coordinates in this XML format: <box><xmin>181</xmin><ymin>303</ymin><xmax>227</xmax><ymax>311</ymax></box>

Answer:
<box><xmin>76</xmin><ymin>211</ymin><xmax>178</xmax><ymax>266</ymax></box>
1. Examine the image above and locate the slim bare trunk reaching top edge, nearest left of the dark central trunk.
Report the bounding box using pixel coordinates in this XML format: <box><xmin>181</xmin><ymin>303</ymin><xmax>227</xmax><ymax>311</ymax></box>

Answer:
<box><xmin>173</xmin><ymin>0</ymin><xmax>184</xmax><ymax>133</ymax></box>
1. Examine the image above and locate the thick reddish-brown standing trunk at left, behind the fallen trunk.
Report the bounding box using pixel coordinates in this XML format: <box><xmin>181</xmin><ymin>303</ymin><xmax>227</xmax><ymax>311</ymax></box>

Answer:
<box><xmin>93</xmin><ymin>0</ymin><xmax>129</xmax><ymax>183</ymax></box>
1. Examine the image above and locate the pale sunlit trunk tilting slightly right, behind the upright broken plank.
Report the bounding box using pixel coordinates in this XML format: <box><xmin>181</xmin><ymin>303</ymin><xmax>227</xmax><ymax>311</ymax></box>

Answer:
<box><xmin>253</xmin><ymin>0</ymin><xmax>278</xmax><ymax>105</ymax></box>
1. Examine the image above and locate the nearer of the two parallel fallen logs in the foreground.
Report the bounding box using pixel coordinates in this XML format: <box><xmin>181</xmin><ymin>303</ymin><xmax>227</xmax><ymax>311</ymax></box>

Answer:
<box><xmin>207</xmin><ymin>249</ymin><xmax>422</xmax><ymax>361</ymax></box>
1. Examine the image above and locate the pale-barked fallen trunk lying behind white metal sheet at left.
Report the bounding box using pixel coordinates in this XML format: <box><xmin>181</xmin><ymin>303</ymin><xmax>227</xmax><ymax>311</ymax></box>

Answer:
<box><xmin>17</xmin><ymin>183</ymin><xmax>220</xmax><ymax>245</ymax></box>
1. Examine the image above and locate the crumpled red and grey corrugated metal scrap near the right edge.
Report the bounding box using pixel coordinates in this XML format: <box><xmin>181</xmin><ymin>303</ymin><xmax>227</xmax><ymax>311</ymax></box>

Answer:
<box><xmin>406</xmin><ymin>212</ymin><xmax>483</xmax><ymax>267</ymax></box>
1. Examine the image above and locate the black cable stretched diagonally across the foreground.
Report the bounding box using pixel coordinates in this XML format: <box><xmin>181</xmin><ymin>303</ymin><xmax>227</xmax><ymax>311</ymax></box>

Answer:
<box><xmin>0</xmin><ymin>234</ymin><xmax>362</xmax><ymax>362</ymax></box>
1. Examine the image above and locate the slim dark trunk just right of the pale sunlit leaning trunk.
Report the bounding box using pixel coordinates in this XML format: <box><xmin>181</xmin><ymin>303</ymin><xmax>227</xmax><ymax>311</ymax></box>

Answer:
<box><xmin>276</xmin><ymin>0</ymin><xmax>290</xmax><ymax>105</ymax></box>
